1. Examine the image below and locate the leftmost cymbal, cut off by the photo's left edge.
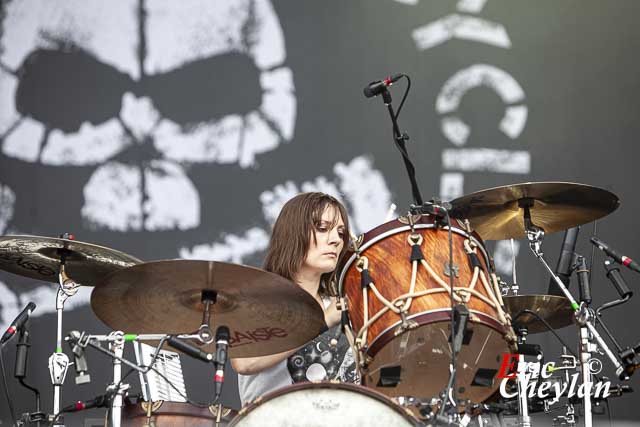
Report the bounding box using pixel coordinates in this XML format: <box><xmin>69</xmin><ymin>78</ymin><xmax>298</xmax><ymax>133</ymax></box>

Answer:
<box><xmin>0</xmin><ymin>236</ymin><xmax>142</xmax><ymax>286</ymax></box>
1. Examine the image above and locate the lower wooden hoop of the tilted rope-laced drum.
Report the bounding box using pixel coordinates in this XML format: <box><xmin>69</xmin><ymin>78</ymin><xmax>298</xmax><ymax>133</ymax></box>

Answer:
<box><xmin>366</xmin><ymin>308</ymin><xmax>507</xmax><ymax>357</ymax></box>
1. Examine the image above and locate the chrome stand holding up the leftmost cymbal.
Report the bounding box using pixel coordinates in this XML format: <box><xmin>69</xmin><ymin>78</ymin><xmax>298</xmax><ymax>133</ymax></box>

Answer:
<box><xmin>49</xmin><ymin>262</ymin><xmax>80</xmax><ymax>426</ymax></box>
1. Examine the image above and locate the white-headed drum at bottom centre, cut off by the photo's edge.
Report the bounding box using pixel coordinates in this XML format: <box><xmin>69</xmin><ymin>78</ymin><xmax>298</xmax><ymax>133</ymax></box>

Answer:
<box><xmin>229</xmin><ymin>382</ymin><xmax>419</xmax><ymax>427</ymax></box>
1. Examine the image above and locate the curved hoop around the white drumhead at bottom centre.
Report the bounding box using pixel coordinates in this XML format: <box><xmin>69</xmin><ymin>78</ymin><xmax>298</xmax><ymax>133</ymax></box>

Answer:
<box><xmin>229</xmin><ymin>381</ymin><xmax>420</xmax><ymax>427</ymax></box>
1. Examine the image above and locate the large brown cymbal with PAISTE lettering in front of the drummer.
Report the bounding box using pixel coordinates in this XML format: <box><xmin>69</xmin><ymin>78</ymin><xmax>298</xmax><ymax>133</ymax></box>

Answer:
<box><xmin>91</xmin><ymin>260</ymin><xmax>325</xmax><ymax>357</ymax></box>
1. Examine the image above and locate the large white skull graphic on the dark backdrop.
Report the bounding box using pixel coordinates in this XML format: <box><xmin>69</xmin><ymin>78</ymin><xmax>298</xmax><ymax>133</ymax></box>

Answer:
<box><xmin>0</xmin><ymin>0</ymin><xmax>296</xmax><ymax>231</ymax></box>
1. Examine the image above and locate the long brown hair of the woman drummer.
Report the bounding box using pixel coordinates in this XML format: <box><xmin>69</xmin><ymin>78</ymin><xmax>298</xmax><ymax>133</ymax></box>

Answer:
<box><xmin>263</xmin><ymin>193</ymin><xmax>349</xmax><ymax>296</ymax></box>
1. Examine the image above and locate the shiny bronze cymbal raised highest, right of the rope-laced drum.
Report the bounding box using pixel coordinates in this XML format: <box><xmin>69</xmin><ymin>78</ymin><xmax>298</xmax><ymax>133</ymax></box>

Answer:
<box><xmin>451</xmin><ymin>182</ymin><xmax>620</xmax><ymax>240</ymax></box>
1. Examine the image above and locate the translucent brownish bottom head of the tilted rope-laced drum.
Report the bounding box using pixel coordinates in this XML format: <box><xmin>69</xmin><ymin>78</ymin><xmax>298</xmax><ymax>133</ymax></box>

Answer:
<box><xmin>362</xmin><ymin>311</ymin><xmax>512</xmax><ymax>403</ymax></box>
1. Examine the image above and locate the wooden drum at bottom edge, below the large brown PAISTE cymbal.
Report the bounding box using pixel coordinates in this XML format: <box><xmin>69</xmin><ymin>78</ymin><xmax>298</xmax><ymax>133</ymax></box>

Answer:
<box><xmin>122</xmin><ymin>401</ymin><xmax>238</xmax><ymax>427</ymax></box>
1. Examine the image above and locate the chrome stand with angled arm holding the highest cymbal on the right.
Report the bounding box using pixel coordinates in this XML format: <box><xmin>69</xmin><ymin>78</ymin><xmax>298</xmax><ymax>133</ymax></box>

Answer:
<box><xmin>519</xmin><ymin>198</ymin><xmax>624</xmax><ymax>427</ymax></box>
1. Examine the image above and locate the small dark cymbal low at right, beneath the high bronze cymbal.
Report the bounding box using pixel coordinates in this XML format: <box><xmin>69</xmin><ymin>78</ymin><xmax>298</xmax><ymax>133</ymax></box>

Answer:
<box><xmin>502</xmin><ymin>295</ymin><xmax>575</xmax><ymax>334</ymax></box>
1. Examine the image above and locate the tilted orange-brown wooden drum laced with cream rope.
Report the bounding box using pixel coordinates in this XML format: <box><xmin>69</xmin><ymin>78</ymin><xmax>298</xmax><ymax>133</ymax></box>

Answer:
<box><xmin>338</xmin><ymin>215</ymin><xmax>515</xmax><ymax>402</ymax></box>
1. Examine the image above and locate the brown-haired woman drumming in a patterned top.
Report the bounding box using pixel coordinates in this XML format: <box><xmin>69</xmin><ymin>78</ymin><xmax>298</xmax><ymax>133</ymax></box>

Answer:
<box><xmin>231</xmin><ymin>193</ymin><xmax>356</xmax><ymax>406</ymax></box>
